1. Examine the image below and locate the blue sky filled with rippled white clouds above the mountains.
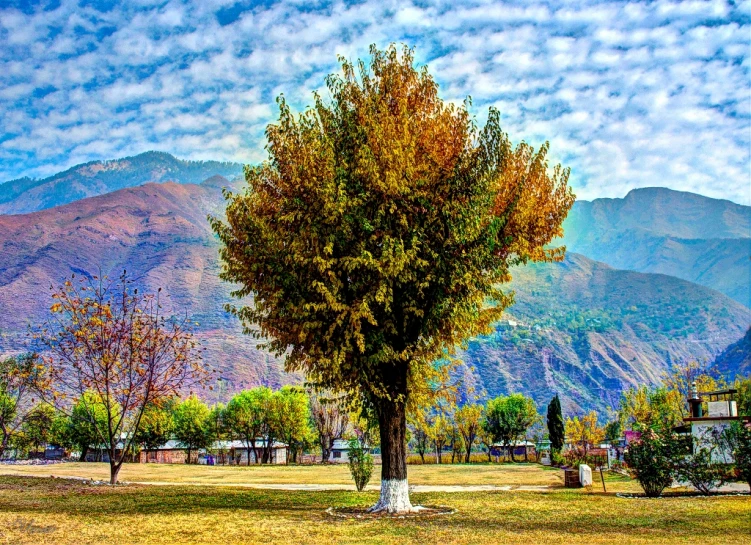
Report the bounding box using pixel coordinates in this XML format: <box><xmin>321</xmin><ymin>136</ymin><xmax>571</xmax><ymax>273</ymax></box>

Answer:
<box><xmin>0</xmin><ymin>0</ymin><xmax>751</xmax><ymax>205</ymax></box>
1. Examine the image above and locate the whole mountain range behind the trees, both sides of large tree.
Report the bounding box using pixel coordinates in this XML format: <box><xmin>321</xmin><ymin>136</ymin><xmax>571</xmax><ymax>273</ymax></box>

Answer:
<box><xmin>0</xmin><ymin>153</ymin><xmax>751</xmax><ymax>413</ymax></box>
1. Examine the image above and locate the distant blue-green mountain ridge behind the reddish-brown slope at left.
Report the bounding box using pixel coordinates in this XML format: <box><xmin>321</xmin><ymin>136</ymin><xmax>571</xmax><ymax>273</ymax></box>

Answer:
<box><xmin>0</xmin><ymin>151</ymin><xmax>243</xmax><ymax>214</ymax></box>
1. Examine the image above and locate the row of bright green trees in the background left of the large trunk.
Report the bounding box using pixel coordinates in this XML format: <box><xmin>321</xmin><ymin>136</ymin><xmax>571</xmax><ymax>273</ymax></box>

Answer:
<box><xmin>0</xmin><ymin>380</ymin><xmax>358</xmax><ymax>464</ymax></box>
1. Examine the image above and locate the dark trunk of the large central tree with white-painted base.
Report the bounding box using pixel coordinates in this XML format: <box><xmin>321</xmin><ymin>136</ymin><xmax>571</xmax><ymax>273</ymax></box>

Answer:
<box><xmin>370</xmin><ymin>394</ymin><xmax>415</xmax><ymax>513</ymax></box>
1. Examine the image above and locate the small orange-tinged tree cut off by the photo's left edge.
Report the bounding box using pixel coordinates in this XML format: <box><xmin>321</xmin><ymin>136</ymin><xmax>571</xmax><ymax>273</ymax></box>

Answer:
<box><xmin>0</xmin><ymin>354</ymin><xmax>47</xmax><ymax>457</ymax></box>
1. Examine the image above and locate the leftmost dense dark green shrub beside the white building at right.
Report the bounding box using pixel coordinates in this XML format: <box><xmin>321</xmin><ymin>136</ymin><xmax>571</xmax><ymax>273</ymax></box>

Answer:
<box><xmin>625</xmin><ymin>430</ymin><xmax>677</xmax><ymax>498</ymax></box>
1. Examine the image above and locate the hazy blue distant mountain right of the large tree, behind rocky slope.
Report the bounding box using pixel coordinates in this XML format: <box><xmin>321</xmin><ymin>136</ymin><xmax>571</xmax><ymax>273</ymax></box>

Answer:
<box><xmin>563</xmin><ymin>188</ymin><xmax>751</xmax><ymax>307</ymax></box>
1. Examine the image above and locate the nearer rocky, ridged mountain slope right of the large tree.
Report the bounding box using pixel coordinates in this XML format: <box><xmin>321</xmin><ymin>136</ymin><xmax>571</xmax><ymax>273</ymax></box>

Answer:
<box><xmin>464</xmin><ymin>253</ymin><xmax>751</xmax><ymax>412</ymax></box>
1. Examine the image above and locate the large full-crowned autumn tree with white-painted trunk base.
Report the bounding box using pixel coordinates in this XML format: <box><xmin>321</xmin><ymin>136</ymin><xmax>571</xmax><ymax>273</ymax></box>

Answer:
<box><xmin>212</xmin><ymin>46</ymin><xmax>574</xmax><ymax>512</ymax></box>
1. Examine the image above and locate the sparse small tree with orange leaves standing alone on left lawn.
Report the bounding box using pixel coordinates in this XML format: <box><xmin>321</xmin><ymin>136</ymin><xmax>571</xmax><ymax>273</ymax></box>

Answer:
<box><xmin>35</xmin><ymin>272</ymin><xmax>206</xmax><ymax>484</ymax></box>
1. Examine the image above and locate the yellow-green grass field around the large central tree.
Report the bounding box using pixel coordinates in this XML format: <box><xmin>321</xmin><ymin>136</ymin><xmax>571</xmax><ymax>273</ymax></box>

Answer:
<box><xmin>0</xmin><ymin>464</ymin><xmax>751</xmax><ymax>545</ymax></box>
